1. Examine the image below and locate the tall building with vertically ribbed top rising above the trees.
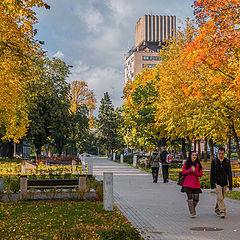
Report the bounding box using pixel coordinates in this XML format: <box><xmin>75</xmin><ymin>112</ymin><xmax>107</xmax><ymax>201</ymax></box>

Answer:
<box><xmin>124</xmin><ymin>15</ymin><xmax>176</xmax><ymax>83</ymax></box>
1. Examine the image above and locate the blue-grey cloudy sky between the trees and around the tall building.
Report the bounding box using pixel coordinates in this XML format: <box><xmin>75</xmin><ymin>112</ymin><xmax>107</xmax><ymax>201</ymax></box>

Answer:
<box><xmin>36</xmin><ymin>0</ymin><xmax>193</xmax><ymax>109</ymax></box>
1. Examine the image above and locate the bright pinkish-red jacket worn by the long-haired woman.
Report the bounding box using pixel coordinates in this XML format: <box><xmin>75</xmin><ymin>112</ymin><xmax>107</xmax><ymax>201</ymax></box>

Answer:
<box><xmin>182</xmin><ymin>162</ymin><xmax>202</xmax><ymax>188</ymax></box>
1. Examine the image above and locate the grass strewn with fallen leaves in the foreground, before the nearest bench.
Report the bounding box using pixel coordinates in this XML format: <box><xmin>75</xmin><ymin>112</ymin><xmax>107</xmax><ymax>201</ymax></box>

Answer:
<box><xmin>0</xmin><ymin>201</ymin><xmax>142</xmax><ymax>240</ymax></box>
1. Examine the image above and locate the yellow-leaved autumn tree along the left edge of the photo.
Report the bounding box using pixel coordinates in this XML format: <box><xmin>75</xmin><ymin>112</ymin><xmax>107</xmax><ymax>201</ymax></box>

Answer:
<box><xmin>0</xmin><ymin>0</ymin><xmax>50</xmax><ymax>141</ymax></box>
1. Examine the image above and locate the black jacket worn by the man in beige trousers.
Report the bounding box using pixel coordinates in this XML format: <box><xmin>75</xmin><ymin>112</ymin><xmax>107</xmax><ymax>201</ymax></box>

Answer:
<box><xmin>210</xmin><ymin>158</ymin><xmax>232</xmax><ymax>190</ymax></box>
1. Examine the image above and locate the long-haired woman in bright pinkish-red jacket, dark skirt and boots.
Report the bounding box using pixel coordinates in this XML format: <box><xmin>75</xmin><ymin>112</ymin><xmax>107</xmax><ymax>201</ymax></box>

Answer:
<box><xmin>181</xmin><ymin>151</ymin><xmax>202</xmax><ymax>218</ymax></box>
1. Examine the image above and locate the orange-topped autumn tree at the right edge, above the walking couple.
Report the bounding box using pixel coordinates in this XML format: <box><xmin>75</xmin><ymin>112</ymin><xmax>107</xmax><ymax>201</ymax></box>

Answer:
<box><xmin>185</xmin><ymin>0</ymin><xmax>240</xmax><ymax>157</ymax></box>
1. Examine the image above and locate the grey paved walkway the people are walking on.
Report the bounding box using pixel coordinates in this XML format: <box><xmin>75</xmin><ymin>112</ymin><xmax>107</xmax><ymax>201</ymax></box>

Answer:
<box><xmin>94</xmin><ymin>158</ymin><xmax>240</xmax><ymax>240</ymax></box>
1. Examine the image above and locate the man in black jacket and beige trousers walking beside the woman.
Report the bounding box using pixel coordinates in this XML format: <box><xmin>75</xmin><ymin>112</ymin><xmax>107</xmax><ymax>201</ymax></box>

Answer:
<box><xmin>210</xmin><ymin>148</ymin><xmax>232</xmax><ymax>218</ymax></box>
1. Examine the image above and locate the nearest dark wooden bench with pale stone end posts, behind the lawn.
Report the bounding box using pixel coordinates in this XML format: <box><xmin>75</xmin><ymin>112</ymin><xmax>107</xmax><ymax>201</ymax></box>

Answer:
<box><xmin>20</xmin><ymin>175</ymin><xmax>86</xmax><ymax>200</ymax></box>
